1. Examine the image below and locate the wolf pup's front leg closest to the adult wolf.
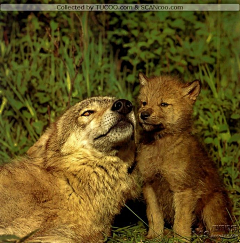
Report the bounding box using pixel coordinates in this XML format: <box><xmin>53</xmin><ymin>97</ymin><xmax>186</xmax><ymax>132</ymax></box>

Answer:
<box><xmin>143</xmin><ymin>184</ymin><xmax>164</xmax><ymax>239</ymax></box>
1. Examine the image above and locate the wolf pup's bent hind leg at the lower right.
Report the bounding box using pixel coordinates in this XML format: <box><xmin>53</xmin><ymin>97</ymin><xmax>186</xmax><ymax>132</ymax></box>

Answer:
<box><xmin>203</xmin><ymin>192</ymin><xmax>231</xmax><ymax>237</ymax></box>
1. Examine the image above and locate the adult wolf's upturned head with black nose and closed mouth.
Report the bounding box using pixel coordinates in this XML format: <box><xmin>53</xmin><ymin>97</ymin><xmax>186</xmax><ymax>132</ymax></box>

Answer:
<box><xmin>28</xmin><ymin>97</ymin><xmax>136</xmax><ymax>157</ymax></box>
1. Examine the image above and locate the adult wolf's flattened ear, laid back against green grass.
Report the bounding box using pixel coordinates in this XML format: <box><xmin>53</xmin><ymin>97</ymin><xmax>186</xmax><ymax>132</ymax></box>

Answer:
<box><xmin>27</xmin><ymin>128</ymin><xmax>52</xmax><ymax>157</ymax></box>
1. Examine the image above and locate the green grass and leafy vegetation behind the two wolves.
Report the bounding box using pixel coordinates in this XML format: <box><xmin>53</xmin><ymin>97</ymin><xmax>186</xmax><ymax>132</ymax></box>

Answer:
<box><xmin>0</xmin><ymin>0</ymin><xmax>240</xmax><ymax>242</ymax></box>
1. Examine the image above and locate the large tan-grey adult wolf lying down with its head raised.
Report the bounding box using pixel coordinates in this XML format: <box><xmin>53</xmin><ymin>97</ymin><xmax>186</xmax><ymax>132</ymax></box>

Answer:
<box><xmin>0</xmin><ymin>97</ymin><xmax>136</xmax><ymax>243</ymax></box>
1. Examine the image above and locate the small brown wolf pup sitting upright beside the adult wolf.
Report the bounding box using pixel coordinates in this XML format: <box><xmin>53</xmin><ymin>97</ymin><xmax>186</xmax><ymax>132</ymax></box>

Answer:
<box><xmin>137</xmin><ymin>74</ymin><xmax>231</xmax><ymax>241</ymax></box>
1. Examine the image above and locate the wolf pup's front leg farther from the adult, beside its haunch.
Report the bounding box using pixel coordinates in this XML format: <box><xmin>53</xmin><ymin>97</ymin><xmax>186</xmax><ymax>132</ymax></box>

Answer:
<box><xmin>173</xmin><ymin>189</ymin><xmax>197</xmax><ymax>241</ymax></box>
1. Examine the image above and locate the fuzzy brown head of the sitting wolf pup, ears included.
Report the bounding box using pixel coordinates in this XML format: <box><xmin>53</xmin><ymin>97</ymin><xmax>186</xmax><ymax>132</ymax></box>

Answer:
<box><xmin>138</xmin><ymin>73</ymin><xmax>201</xmax><ymax>135</ymax></box>
